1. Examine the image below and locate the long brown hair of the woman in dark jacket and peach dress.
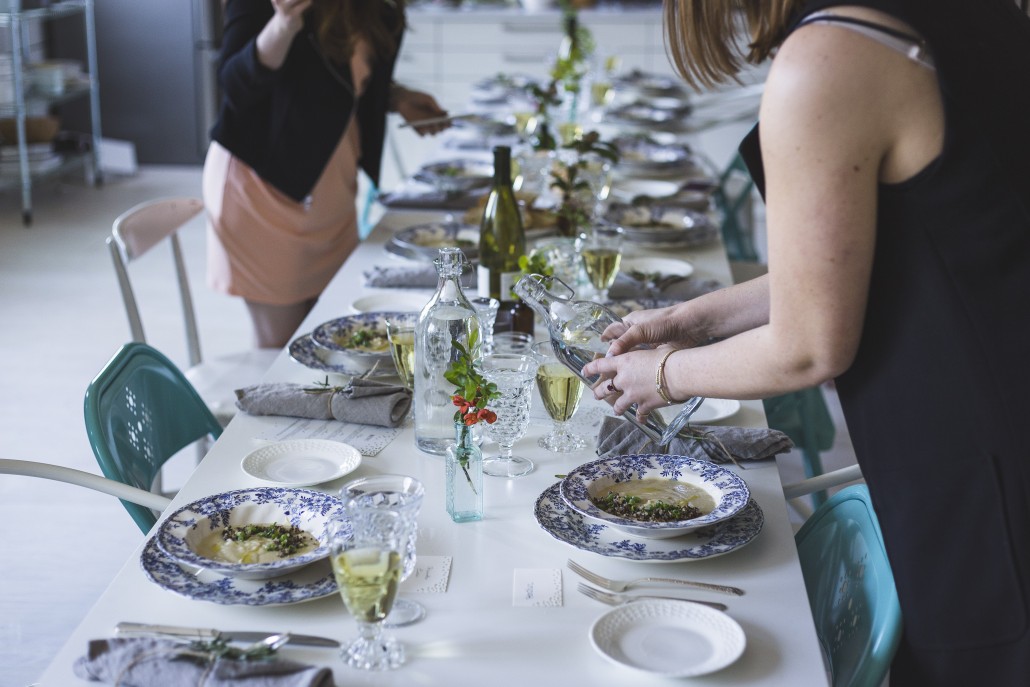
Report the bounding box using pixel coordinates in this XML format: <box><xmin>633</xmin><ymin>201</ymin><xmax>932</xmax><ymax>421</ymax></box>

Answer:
<box><xmin>311</xmin><ymin>0</ymin><xmax>406</xmax><ymax>63</ymax></box>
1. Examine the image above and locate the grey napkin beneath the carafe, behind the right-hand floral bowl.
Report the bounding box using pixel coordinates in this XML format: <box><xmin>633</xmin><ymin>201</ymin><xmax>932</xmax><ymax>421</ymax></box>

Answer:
<box><xmin>597</xmin><ymin>417</ymin><xmax>794</xmax><ymax>462</ymax></box>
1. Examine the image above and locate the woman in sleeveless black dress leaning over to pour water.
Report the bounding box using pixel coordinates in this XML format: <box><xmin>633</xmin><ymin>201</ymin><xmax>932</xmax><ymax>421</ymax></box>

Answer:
<box><xmin>584</xmin><ymin>0</ymin><xmax>1030</xmax><ymax>686</ymax></box>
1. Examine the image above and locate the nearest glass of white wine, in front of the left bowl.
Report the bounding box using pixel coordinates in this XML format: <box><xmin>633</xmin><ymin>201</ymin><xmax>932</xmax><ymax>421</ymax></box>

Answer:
<box><xmin>329</xmin><ymin>508</ymin><xmax>408</xmax><ymax>671</ymax></box>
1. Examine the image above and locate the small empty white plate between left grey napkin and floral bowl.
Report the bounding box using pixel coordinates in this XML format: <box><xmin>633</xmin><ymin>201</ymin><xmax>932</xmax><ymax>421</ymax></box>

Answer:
<box><xmin>240</xmin><ymin>439</ymin><xmax>362</xmax><ymax>486</ymax></box>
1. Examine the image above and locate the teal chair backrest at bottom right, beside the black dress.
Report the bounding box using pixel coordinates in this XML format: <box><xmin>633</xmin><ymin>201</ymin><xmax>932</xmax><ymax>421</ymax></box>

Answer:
<box><xmin>794</xmin><ymin>484</ymin><xmax>901</xmax><ymax>687</ymax></box>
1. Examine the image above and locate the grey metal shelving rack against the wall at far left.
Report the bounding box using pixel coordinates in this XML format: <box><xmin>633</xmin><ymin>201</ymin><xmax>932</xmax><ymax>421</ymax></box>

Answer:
<box><xmin>0</xmin><ymin>0</ymin><xmax>100</xmax><ymax>226</ymax></box>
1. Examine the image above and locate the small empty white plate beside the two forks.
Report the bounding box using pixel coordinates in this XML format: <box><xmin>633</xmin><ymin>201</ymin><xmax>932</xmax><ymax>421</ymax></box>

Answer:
<box><xmin>590</xmin><ymin>600</ymin><xmax>747</xmax><ymax>678</ymax></box>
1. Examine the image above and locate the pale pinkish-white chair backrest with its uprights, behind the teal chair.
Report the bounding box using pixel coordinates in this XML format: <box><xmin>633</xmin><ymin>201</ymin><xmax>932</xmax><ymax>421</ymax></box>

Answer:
<box><xmin>107</xmin><ymin>198</ymin><xmax>204</xmax><ymax>367</ymax></box>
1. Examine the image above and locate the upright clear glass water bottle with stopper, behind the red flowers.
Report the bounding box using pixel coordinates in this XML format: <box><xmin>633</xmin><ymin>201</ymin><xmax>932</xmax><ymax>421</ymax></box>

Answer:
<box><xmin>414</xmin><ymin>247</ymin><xmax>479</xmax><ymax>455</ymax></box>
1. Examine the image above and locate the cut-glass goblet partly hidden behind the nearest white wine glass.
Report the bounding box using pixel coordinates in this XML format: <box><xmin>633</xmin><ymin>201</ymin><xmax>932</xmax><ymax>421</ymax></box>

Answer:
<box><xmin>340</xmin><ymin>475</ymin><xmax>425</xmax><ymax>627</ymax></box>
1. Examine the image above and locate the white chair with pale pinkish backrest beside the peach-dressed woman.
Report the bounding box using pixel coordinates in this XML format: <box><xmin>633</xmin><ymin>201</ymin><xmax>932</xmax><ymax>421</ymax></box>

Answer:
<box><xmin>107</xmin><ymin>198</ymin><xmax>278</xmax><ymax>425</ymax></box>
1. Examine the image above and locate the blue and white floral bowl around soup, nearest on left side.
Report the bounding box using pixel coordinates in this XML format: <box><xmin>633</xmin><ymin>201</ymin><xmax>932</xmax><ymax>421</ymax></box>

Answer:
<box><xmin>157</xmin><ymin>487</ymin><xmax>343</xmax><ymax>580</ymax></box>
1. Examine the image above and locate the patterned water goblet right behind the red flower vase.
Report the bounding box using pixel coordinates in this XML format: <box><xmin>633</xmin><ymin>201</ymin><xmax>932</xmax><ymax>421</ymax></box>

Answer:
<box><xmin>475</xmin><ymin>352</ymin><xmax>539</xmax><ymax>477</ymax></box>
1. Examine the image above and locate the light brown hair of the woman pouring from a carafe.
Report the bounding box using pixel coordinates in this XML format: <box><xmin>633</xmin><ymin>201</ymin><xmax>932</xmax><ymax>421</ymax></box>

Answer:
<box><xmin>663</xmin><ymin>0</ymin><xmax>802</xmax><ymax>88</ymax></box>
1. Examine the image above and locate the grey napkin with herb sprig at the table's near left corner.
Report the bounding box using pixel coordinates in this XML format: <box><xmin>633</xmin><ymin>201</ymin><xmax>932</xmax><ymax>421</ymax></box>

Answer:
<box><xmin>73</xmin><ymin>638</ymin><xmax>334</xmax><ymax>687</ymax></box>
